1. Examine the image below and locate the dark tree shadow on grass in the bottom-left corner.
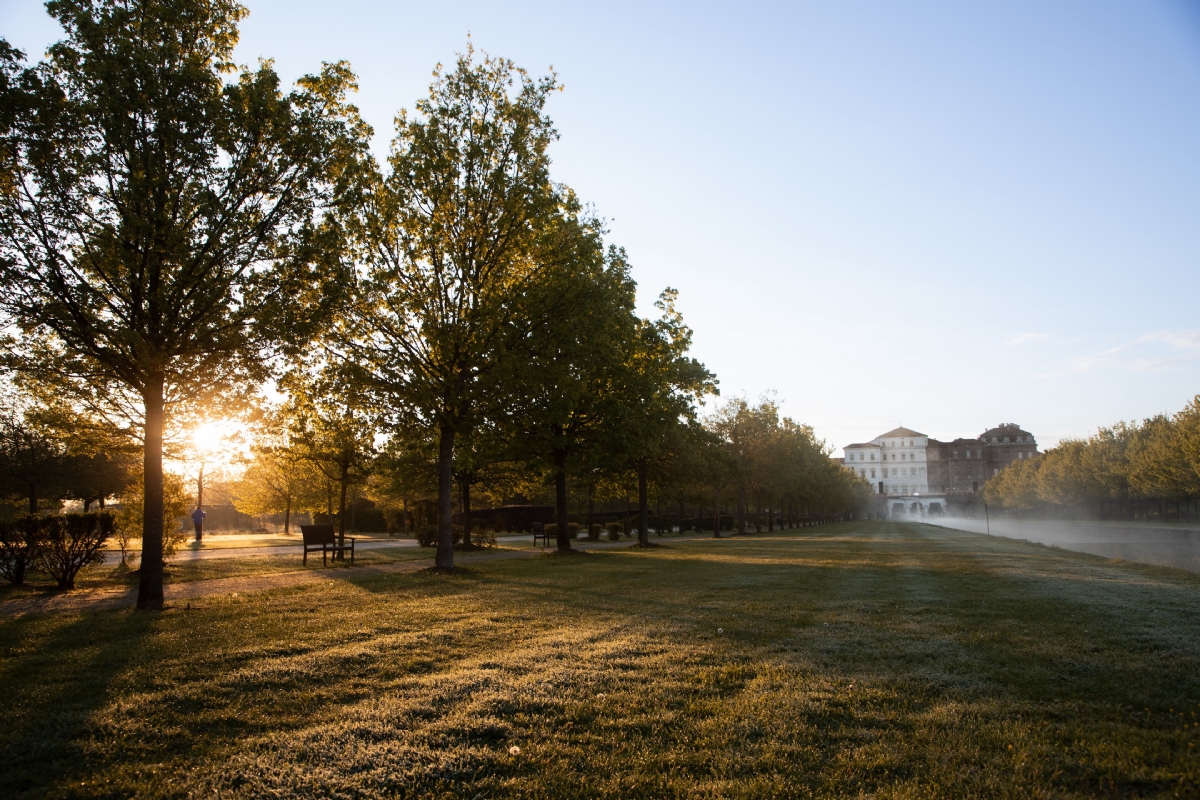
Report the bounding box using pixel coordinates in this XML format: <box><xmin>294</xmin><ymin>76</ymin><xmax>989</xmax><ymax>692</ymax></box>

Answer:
<box><xmin>0</xmin><ymin>612</ymin><xmax>158</xmax><ymax>798</ymax></box>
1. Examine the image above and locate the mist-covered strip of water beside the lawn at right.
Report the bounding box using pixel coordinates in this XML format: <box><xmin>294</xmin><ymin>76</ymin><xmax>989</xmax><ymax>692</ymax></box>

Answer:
<box><xmin>923</xmin><ymin>517</ymin><xmax>1200</xmax><ymax>572</ymax></box>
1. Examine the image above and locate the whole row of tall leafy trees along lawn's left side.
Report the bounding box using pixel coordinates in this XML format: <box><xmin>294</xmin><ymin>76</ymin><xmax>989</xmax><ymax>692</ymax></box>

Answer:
<box><xmin>0</xmin><ymin>0</ymin><xmax>858</xmax><ymax>607</ymax></box>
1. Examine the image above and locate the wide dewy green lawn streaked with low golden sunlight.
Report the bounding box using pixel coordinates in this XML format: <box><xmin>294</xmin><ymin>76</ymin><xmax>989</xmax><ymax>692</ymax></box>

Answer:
<box><xmin>0</xmin><ymin>523</ymin><xmax>1200</xmax><ymax>798</ymax></box>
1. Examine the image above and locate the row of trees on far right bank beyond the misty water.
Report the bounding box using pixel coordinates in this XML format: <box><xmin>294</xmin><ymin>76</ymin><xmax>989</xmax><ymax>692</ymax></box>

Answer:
<box><xmin>983</xmin><ymin>396</ymin><xmax>1200</xmax><ymax>521</ymax></box>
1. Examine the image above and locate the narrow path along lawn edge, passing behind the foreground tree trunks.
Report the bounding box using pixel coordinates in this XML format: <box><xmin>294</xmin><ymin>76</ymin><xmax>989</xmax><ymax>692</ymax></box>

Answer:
<box><xmin>0</xmin><ymin>536</ymin><xmax>709</xmax><ymax>618</ymax></box>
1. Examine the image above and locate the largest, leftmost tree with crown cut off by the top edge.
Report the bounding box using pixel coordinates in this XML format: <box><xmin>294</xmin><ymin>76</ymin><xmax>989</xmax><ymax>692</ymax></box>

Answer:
<box><xmin>0</xmin><ymin>0</ymin><xmax>367</xmax><ymax>608</ymax></box>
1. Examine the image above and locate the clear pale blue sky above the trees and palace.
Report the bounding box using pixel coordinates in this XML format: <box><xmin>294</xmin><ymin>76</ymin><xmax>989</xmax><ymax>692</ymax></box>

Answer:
<box><xmin>0</xmin><ymin>0</ymin><xmax>1200</xmax><ymax>447</ymax></box>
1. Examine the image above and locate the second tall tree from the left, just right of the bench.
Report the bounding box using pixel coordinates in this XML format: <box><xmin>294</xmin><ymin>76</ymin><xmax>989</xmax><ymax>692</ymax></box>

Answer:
<box><xmin>346</xmin><ymin>46</ymin><xmax>560</xmax><ymax>569</ymax></box>
